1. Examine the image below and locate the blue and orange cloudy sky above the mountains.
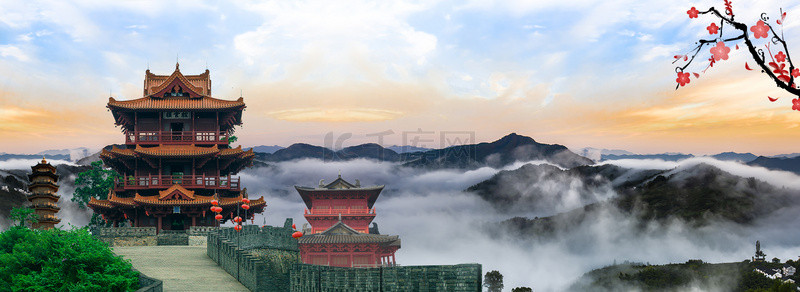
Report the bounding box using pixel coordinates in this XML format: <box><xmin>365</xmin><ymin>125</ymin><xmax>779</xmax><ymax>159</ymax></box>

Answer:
<box><xmin>0</xmin><ymin>0</ymin><xmax>800</xmax><ymax>154</ymax></box>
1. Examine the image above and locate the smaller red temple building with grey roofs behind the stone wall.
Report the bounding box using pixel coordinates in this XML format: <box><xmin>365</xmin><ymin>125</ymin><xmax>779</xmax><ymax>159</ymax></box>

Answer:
<box><xmin>295</xmin><ymin>175</ymin><xmax>400</xmax><ymax>267</ymax></box>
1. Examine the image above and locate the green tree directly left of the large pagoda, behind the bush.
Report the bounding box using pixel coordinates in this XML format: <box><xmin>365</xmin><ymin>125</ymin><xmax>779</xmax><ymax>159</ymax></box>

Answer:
<box><xmin>72</xmin><ymin>161</ymin><xmax>122</xmax><ymax>226</ymax></box>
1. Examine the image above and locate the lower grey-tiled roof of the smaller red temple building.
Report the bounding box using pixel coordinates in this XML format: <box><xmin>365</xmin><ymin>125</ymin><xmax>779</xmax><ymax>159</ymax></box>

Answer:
<box><xmin>298</xmin><ymin>220</ymin><xmax>400</xmax><ymax>248</ymax></box>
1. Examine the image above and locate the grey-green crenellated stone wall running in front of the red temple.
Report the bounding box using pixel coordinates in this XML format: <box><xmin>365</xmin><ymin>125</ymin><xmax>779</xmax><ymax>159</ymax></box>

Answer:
<box><xmin>206</xmin><ymin>219</ymin><xmax>482</xmax><ymax>292</ymax></box>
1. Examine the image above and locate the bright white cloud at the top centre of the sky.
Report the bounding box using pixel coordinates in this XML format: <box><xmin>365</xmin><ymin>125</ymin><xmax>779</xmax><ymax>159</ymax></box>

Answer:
<box><xmin>234</xmin><ymin>1</ymin><xmax>437</xmax><ymax>76</ymax></box>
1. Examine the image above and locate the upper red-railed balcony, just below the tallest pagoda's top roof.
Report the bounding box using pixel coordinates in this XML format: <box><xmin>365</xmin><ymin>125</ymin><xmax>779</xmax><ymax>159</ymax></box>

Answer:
<box><xmin>125</xmin><ymin>131</ymin><xmax>230</xmax><ymax>145</ymax></box>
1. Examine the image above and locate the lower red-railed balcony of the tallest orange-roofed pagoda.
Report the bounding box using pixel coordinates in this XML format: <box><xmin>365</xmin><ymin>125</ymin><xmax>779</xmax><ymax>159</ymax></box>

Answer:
<box><xmin>114</xmin><ymin>175</ymin><xmax>240</xmax><ymax>192</ymax></box>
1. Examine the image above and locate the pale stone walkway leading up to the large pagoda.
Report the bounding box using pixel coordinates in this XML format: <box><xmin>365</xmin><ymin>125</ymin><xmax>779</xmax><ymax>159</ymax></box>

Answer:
<box><xmin>113</xmin><ymin>246</ymin><xmax>250</xmax><ymax>291</ymax></box>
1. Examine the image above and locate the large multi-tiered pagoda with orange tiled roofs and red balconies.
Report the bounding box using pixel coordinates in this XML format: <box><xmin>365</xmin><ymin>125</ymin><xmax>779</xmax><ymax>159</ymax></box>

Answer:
<box><xmin>88</xmin><ymin>65</ymin><xmax>266</xmax><ymax>231</ymax></box>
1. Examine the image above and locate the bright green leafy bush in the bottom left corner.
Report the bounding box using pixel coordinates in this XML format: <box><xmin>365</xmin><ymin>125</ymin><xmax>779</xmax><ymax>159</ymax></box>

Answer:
<box><xmin>0</xmin><ymin>226</ymin><xmax>139</xmax><ymax>292</ymax></box>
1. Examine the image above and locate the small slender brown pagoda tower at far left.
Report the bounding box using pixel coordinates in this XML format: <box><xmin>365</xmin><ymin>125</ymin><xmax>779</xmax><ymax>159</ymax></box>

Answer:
<box><xmin>28</xmin><ymin>157</ymin><xmax>61</xmax><ymax>229</ymax></box>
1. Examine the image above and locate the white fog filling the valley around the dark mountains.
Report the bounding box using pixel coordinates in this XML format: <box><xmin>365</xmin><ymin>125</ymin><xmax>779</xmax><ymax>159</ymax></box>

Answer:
<box><xmin>240</xmin><ymin>158</ymin><xmax>800</xmax><ymax>291</ymax></box>
